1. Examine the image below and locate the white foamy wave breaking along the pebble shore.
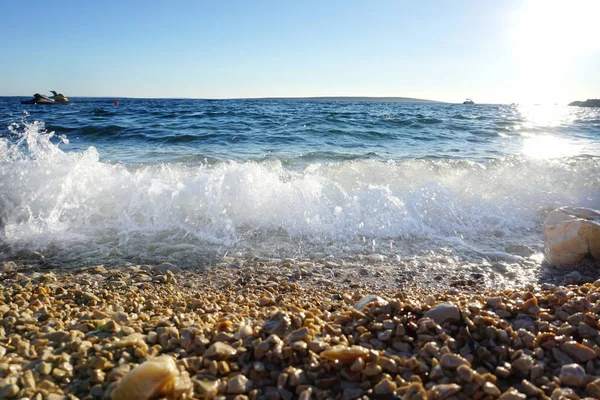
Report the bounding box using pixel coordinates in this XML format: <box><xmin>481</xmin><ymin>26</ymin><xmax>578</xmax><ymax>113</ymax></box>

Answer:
<box><xmin>0</xmin><ymin>122</ymin><xmax>600</xmax><ymax>268</ymax></box>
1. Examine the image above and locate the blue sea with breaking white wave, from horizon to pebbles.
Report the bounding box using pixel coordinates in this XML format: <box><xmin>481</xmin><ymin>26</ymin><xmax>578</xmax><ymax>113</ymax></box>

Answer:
<box><xmin>0</xmin><ymin>97</ymin><xmax>600</xmax><ymax>279</ymax></box>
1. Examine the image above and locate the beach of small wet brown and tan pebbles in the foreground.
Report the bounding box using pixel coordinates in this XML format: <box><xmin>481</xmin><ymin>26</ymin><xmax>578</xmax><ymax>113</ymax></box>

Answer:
<box><xmin>0</xmin><ymin>258</ymin><xmax>600</xmax><ymax>400</ymax></box>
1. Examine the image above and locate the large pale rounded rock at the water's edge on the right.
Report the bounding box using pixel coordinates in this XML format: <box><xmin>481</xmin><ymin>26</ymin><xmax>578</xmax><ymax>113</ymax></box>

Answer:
<box><xmin>544</xmin><ymin>207</ymin><xmax>600</xmax><ymax>265</ymax></box>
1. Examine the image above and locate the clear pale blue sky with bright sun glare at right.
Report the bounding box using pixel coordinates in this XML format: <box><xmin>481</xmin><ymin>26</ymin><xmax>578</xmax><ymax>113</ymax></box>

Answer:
<box><xmin>0</xmin><ymin>0</ymin><xmax>600</xmax><ymax>103</ymax></box>
